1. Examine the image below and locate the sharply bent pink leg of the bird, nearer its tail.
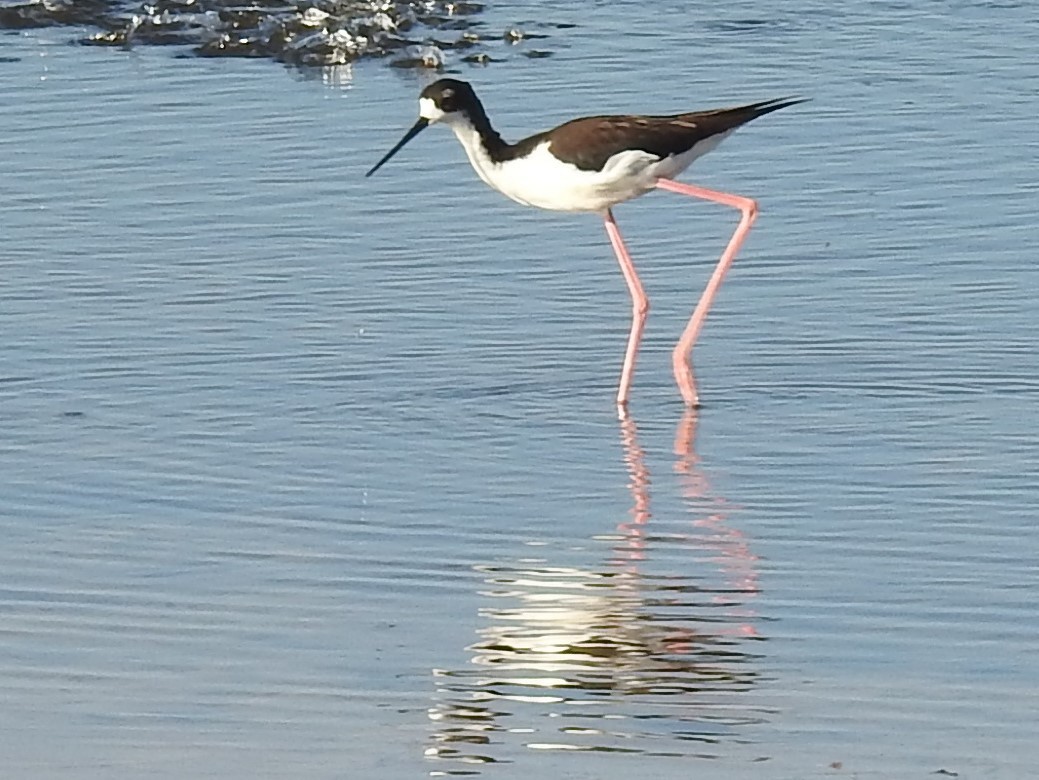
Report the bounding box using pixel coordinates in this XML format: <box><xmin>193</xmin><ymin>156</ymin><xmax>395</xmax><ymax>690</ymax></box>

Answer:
<box><xmin>657</xmin><ymin>179</ymin><xmax>757</xmax><ymax>406</ymax></box>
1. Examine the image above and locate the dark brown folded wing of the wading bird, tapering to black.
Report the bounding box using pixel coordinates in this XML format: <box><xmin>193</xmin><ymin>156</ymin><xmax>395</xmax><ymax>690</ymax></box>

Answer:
<box><xmin>527</xmin><ymin>99</ymin><xmax>804</xmax><ymax>170</ymax></box>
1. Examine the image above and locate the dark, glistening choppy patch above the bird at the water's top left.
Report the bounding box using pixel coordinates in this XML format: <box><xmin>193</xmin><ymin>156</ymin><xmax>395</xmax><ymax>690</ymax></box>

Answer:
<box><xmin>0</xmin><ymin>0</ymin><xmax>552</xmax><ymax>69</ymax></box>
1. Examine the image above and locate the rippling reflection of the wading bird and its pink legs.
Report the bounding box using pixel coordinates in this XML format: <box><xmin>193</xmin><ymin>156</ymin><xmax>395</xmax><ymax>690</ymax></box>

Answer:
<box><xmin>426</xmin><ymin>411</ymin><xmax>767</xmax><ymax>775</ymax></box>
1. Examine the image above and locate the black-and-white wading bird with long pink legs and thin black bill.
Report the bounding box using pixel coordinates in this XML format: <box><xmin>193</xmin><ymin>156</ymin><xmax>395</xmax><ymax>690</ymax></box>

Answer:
<box><xmin>365</xmin><ymin>78</ymin><xmax>805</xmax><ymax>419</ymax></box>
